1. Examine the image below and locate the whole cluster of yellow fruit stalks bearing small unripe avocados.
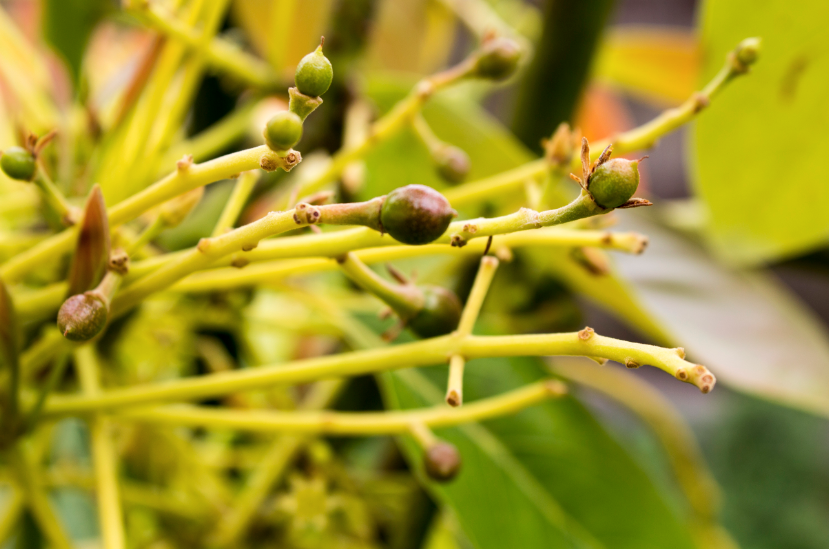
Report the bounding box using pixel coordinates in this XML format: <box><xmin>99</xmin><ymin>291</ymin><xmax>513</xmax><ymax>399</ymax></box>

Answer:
<box><xmin>0</xmin><ymin>17</ymin><xmax>759</xmax><ymax>535</ymax></box>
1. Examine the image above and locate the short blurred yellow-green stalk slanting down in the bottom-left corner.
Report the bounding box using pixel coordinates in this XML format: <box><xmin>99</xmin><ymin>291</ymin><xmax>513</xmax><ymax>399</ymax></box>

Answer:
<box><xmin>8</xmin><ymin>442</ymin><xmax>72</xmax><ymax>549</ymax></box>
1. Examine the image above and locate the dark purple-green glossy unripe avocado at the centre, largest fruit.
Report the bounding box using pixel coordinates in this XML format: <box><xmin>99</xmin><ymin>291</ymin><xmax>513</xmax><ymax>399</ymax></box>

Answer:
<box><xmin>380</xmin><ymin>185</ymin><xmax>457</xmax><ymax>245</ymax></box>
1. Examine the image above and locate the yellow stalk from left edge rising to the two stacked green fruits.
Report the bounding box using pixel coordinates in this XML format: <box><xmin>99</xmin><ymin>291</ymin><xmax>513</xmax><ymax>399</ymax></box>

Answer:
<box><xmin>0</xmin><ymin>145</ymin><xmax>281</xmax><ymax>283</ymax></box>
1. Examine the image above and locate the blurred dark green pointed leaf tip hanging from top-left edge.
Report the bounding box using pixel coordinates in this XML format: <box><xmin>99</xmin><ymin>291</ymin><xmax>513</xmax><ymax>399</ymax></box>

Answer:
<box><xmin>43</xmin><ymin>0</ymin><xmax>111</xmax><ymax>83</ymax></box>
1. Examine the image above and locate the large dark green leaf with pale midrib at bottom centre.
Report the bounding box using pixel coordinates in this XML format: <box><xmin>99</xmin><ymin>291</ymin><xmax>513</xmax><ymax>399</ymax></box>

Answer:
<box><xmin>383</xmin><ymin>359</ymin><xmax>692</xmax><ymax>549</ymax></box>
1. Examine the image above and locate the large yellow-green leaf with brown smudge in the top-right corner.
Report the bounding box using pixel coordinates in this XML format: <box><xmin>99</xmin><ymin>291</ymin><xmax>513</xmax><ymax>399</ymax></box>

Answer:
<box><xmin>693</xmin><ymin>0</ymin><xmax>829</xmax><ymax>264</ymax></box>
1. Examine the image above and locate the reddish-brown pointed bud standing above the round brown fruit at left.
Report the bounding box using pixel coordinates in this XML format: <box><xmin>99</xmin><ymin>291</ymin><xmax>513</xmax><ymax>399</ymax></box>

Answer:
<box><xmin>68</xmin><ymin>185</ymin><xmax>109</xmax><ymax>295</ymax></box>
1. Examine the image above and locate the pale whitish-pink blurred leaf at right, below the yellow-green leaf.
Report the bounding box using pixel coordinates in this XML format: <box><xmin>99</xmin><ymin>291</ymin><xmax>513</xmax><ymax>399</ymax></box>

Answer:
<box><xmin>616</xmin><ymin>212</ymin><xmax>829</xmax><ymax>415</ymax></box>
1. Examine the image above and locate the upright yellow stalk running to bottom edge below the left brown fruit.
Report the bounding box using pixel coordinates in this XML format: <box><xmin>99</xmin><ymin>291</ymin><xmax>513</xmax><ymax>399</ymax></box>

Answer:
<box><xmin>75</xmin><ymin>345</ymin><xmax>126</xmax><ymax>549</ymax></box>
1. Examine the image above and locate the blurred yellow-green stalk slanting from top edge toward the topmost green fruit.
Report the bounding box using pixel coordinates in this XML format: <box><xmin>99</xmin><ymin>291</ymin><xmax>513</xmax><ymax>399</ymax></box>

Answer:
<box><xmin>133</xmin><ymin>2</ymin><xmax>277</xmax><ymax>88</ymax></box>
